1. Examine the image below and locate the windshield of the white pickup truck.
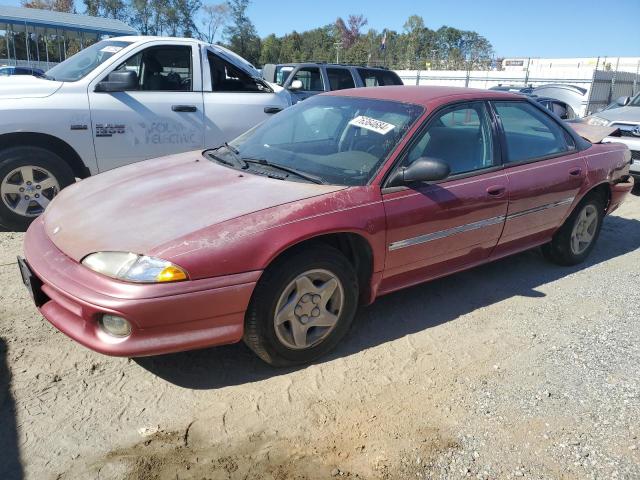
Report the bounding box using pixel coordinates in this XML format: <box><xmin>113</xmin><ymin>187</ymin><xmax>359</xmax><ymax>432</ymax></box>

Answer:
<box><xmin>46</xmin><ymin>40</ymin><xmax>131</xmax><ymax>82</ymax></box>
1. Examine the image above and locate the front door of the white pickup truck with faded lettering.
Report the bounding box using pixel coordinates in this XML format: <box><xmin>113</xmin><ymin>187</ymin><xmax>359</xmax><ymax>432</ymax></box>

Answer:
<box><xmin>88</xmin><ymin>41</ymin><xmax>204</xmax><ymax>171</ymax></box>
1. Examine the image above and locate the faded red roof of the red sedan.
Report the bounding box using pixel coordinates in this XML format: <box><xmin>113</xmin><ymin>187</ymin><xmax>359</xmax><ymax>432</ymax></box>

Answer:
<box><xmin>322</xmin><ymin>85</ymin><xmax>524</xmax><ymax>106</ymax></box>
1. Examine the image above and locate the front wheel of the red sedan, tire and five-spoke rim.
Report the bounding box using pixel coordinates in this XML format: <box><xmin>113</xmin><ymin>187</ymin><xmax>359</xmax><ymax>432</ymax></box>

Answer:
<box><xmin>244</xmin><ymin>244</ymin><xmax>358</xmax><ymax>366</ymax></box>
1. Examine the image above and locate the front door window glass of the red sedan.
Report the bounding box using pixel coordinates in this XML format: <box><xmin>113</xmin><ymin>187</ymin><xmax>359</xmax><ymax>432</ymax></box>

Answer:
<box><xmin>403</xmin><ymin>102</ymin><xmax>494</xmax><ymax>175</ymax></box>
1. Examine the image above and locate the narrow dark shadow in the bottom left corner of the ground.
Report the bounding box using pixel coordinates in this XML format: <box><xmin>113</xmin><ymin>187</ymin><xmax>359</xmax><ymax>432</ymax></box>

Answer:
<box><xmin>0</xmin><ymin>338</ymin><xmax>23</xmax><ymax>480</ymax></box>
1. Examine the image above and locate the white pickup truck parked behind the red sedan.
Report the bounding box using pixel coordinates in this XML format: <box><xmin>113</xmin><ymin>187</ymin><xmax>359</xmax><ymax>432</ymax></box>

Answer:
<box><xmin>0</xmin><ymin>37</ymin><xmax>291</xmax><ymax>228</ymax></box>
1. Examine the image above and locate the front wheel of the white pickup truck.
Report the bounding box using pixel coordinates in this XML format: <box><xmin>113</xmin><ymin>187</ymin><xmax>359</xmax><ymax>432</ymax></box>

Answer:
<box><xmin>0</xmin><ymin>147</ymin><xmax>75</xmax><ymax>230</ymax></box>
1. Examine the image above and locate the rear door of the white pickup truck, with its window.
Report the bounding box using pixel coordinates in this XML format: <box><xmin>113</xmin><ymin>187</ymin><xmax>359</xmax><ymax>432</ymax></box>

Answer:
<box><xmin>202</xmin><ymin>46</ymin><xmax>291</xmax><ymax>147</ymax></box>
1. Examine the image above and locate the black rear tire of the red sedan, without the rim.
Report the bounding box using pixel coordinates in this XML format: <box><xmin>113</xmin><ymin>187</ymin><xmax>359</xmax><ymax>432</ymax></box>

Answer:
<box><xmin>542</xmin><ymin>193</ymin><xmax>604</xmax><ymax>266</ymax></box>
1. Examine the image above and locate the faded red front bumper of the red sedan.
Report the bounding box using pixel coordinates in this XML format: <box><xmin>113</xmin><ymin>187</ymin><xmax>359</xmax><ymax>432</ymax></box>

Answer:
<box><xmin>24</xmin><ymin>218</ymin><xmax>261</xmax><ymax>357</ymax></box>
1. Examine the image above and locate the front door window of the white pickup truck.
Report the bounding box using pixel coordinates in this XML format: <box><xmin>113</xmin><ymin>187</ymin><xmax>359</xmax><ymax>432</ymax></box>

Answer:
<box><xmin>117</xmin><ymin>45</ymin><xmax>193</xmax><ymax>92</ymax></box>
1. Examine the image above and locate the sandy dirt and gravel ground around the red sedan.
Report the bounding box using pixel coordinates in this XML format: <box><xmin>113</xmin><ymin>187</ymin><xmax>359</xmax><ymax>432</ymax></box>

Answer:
<box><xmin>0</xmin><ymin>189</ymin><xmax>640</xmax><ymax>480</ymax></box>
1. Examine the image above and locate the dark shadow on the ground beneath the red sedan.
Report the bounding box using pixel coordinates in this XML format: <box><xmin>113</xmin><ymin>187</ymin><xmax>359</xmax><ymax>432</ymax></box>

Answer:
<box><xmin>135</xmin><ymin>217</ymin><xmax>640</xmax><ymax>389</ymax></box>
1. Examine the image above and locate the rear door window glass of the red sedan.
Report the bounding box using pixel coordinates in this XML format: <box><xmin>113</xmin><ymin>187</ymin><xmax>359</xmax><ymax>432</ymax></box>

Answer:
<box><xmin>493</xmin><ymin>102</ymin><xmax>570</xmax><ymax>163</ymax></box>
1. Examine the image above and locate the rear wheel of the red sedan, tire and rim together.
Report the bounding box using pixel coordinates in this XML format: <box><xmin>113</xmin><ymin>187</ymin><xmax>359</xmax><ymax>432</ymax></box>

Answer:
<box><xmin>542</xmin><ymin>194</ymin><xmax>604</xmax><ymax>266</ymax></box>
